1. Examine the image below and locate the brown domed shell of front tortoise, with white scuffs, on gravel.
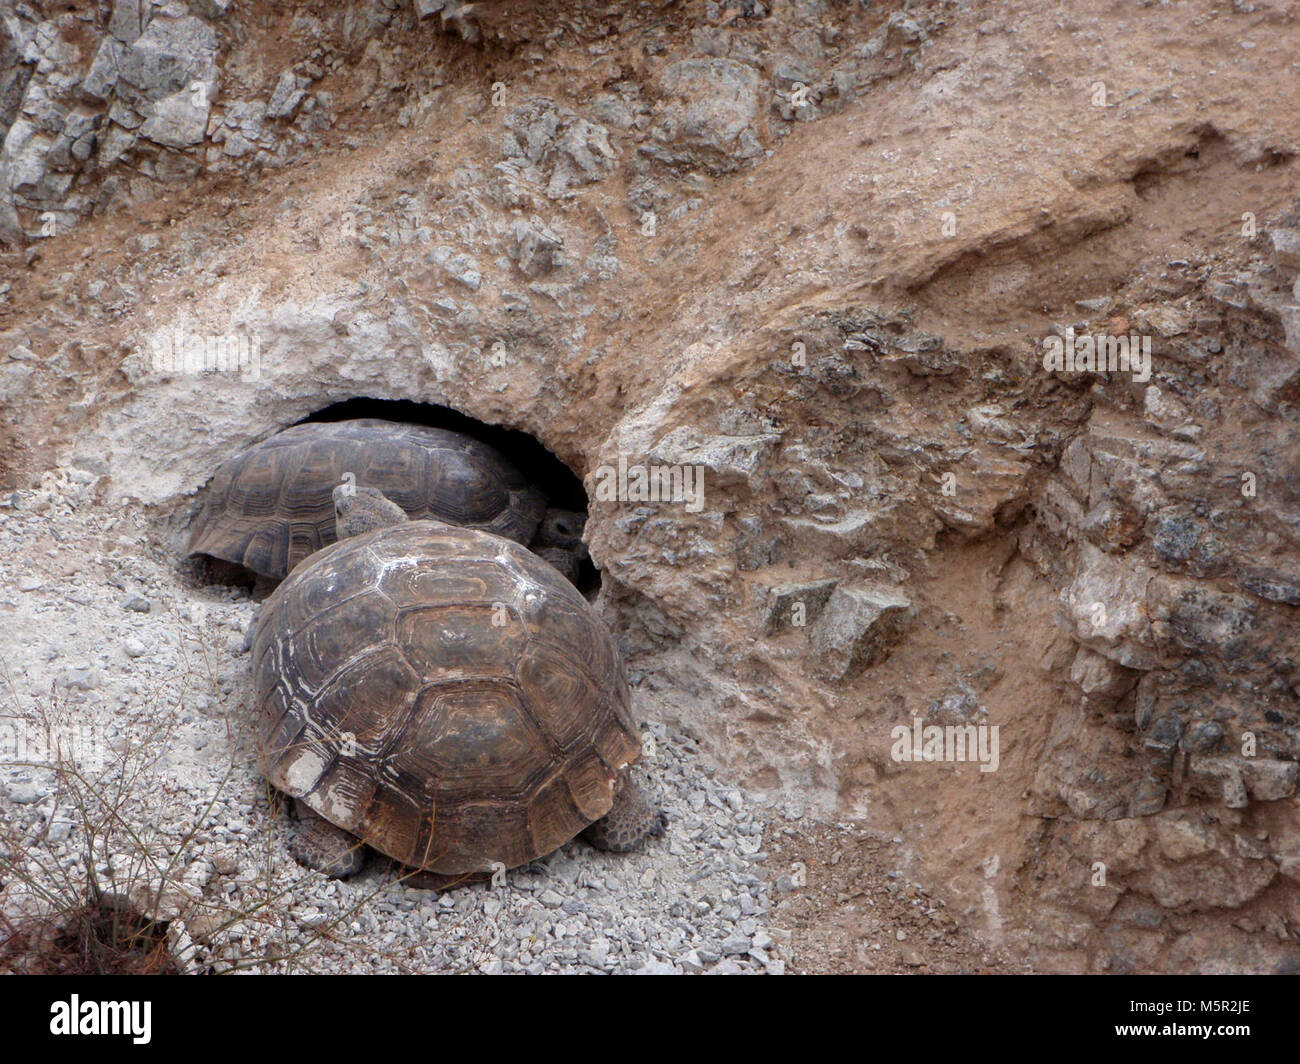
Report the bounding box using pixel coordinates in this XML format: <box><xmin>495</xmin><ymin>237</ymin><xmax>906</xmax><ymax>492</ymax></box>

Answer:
<box><xmin>254</xmin><ymin>522</ymin><xmax>640</xmax><ymax>875</ymax></box>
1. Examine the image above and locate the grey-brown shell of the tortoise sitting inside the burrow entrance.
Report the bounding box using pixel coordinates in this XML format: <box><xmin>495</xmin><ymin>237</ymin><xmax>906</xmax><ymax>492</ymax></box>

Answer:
<box><xmin>190</xmin><ymin>419</ymin><xmax>546</xmax><ymax>580</ymax></box>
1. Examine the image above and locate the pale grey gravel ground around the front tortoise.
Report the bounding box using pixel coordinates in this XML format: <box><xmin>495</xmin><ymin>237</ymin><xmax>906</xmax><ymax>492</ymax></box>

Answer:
<box><xmin>0</xmin><ymin>481</ymin><xmax>789</xmax><ymax>974</ymax></box>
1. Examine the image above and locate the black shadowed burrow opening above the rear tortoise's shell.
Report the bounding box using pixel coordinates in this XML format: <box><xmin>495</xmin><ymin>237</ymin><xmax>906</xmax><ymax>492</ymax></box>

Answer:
<box><xmin>299</xmin><ymin>398</ymin><xmax>601</xmax><ymax>598</ymax></box>
